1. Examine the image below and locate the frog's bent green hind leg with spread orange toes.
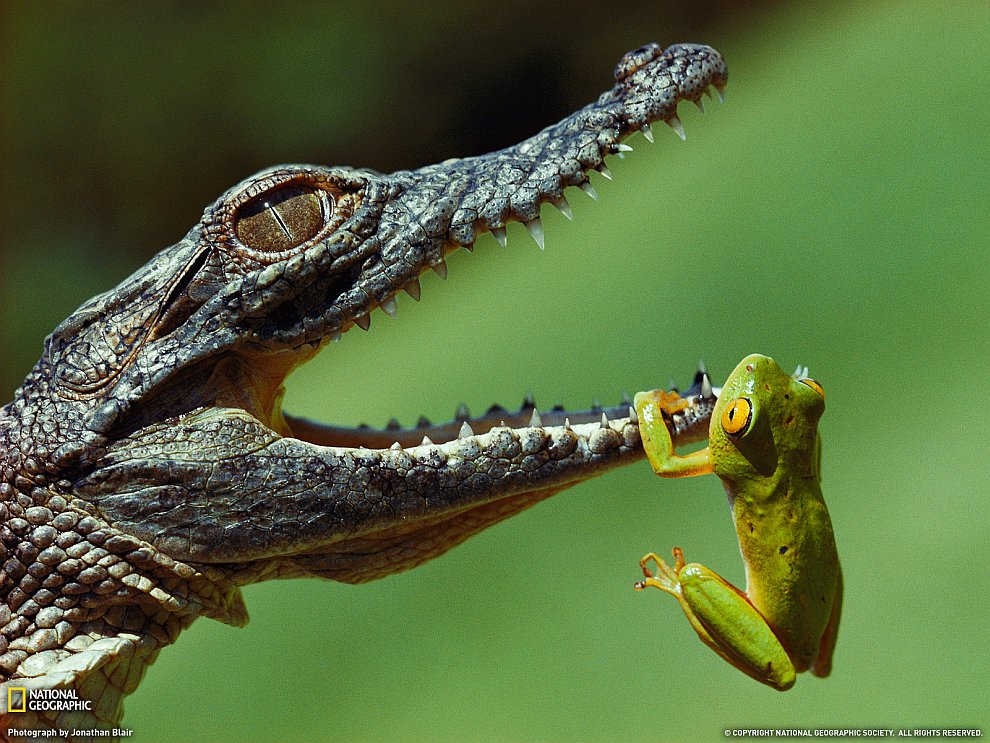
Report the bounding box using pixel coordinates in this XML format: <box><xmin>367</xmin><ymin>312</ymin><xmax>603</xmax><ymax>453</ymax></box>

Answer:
<box><xmin>635</xmin><ymin>547</ymin><xmax>796</xmax><ymax>691</ymax></box>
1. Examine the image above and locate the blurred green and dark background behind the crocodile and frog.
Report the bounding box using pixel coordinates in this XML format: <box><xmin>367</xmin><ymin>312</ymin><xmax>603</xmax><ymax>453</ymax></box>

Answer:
<box><xmin>0</xmin><ymin>0</ymin><xmax>990</xmax><ymax>741</ymax></box>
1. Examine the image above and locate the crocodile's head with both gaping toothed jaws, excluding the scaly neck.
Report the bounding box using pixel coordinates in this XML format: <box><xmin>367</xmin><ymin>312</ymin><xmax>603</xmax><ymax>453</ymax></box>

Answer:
<box><xmin>64</xmin><ymin>44</ymin><xmax>727</xmax><ymax>583</ymax></box>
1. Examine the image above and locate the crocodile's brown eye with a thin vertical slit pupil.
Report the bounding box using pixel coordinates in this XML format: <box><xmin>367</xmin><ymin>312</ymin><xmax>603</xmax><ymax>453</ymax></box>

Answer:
<box><xmin>235</xmin><ymin>185</ymin><xmax>333</xmax><ymax>253</ymax></box>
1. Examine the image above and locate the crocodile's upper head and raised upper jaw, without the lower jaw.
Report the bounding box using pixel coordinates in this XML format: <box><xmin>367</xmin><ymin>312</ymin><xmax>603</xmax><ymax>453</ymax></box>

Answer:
<box><xmin>42</xmin><ymin>44</ymin><xmax>726</xmax><ymax>451</ymax></box>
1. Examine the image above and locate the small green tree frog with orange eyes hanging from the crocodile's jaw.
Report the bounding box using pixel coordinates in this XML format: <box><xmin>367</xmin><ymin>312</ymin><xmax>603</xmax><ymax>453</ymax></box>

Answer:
<box><xmin>634</xmin><ymin>355</ymin><xmax>842</xmax><ymax>691</ymax></box>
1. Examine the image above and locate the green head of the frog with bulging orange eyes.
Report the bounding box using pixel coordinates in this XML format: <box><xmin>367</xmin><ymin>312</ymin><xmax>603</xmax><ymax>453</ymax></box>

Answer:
<box><xmin>709</xmin><ymin>354</ymin><xmax>825</xmax><ymax>480</ymax></box>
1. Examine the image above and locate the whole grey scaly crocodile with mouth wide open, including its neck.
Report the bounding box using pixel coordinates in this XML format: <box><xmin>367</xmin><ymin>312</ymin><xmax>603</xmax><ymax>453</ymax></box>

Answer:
<box><xmin>0</xmin><ymin>44</ymin><xmax>727</xmax><ymax>740</ymax></box>
